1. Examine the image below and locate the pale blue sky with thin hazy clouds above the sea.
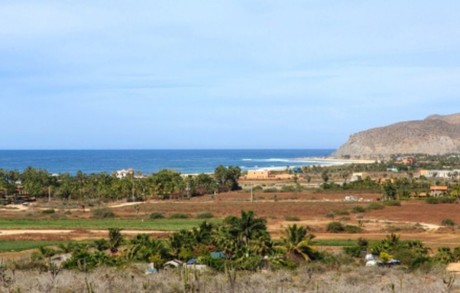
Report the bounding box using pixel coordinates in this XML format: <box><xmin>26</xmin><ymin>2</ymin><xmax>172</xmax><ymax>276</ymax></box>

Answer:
<box><xmin>0</xmin><ymin>0</ymin><xmax>460</xmax><ymax>149</ymax></box>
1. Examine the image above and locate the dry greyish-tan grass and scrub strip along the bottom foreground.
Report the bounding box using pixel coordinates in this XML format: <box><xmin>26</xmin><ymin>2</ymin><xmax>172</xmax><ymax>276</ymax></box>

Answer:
<box><xmin>0</xmin><ymin>264</ymin><xmax>460</xmax><ymax>293</ymax></box>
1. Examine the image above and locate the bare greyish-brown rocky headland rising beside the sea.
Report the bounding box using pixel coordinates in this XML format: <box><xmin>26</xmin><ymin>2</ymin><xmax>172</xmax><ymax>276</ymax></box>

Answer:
<box><xmin>335</xmin><ymin>113</ymin><xmax>460</xmax><ymax>158</ymax></box>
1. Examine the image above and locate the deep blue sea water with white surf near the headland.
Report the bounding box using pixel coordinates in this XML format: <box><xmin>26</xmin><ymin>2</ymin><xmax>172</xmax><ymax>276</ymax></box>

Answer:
<box><xmin>0</xmin><ymin>149</ymin><xmax>334</xmax><ymax>174</ymax></box>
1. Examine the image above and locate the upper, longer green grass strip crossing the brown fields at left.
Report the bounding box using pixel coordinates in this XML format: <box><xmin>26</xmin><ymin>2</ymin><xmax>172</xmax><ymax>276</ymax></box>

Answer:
<box><xmin>0</xmin><ymin>218</ymin><xmax>219</xmax><ymax>231</ymax></box>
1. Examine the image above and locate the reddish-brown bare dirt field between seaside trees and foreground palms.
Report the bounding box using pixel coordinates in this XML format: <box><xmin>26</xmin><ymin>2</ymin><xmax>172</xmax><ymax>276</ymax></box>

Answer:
<box><xmin>0</xmin><ymin>192</ymin><xmax>460</xmax><ymax>248</ymax></box>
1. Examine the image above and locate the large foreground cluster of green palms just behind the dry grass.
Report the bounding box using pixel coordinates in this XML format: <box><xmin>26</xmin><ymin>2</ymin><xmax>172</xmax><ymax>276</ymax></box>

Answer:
<box><xmin>45</xmin><ymin>211</ymin><xmax>320</xmax><ymax>270</ymax></box>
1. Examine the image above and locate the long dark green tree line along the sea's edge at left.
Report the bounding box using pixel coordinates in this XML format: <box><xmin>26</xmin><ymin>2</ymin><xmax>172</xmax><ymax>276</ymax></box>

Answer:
<box><xmin>0</xmin><ymin>165</ymin><xmax>241</xmax><ymax>200</ymax></box>
